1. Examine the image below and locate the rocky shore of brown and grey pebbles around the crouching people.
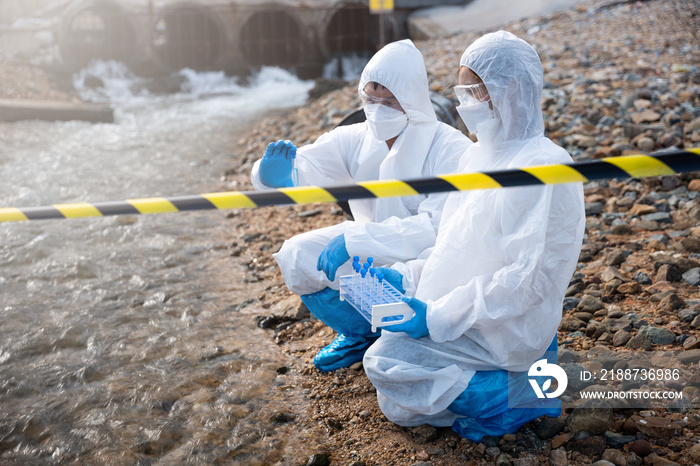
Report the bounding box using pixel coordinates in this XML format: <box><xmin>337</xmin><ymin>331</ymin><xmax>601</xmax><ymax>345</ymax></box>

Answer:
<box><xmin>226</xmin><ymin>0</ymin><xmax>700</xmax><ymax>466</ymax></box>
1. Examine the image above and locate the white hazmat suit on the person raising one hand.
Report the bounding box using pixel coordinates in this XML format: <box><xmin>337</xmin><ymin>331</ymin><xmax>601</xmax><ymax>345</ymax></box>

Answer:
<box><xmin>251</xmin><ymin>40</ymin><xmax>471</xmax><ymax>295</ymax></box>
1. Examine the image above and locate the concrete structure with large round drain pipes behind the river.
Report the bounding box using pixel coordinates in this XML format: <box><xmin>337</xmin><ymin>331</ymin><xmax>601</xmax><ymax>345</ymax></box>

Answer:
<box><xmin>5</xmin><ymin>0</ymin><xmax>476</xmax><ymax>77</ymax></box>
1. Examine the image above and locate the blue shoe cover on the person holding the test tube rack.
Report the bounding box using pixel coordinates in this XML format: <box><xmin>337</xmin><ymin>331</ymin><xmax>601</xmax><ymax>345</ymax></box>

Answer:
<box><xmin>447</xmin><ymin>338</ymin><xmax>561</xmax><ymax>442</ymax></box>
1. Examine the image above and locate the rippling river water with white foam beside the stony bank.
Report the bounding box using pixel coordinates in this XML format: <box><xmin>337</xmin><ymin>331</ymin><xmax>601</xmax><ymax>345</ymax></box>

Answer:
<box><xmin>0</xmin><ymin>63</ymin><xmax>313</xmax><ymax>465</ymax></box>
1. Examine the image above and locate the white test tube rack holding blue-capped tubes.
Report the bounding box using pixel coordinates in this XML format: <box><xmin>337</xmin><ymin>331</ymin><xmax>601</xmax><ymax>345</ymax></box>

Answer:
<box><xmin>340</xmin><ymin>274</ymin><xmax>415</xmax><ymax>332</ymax></box>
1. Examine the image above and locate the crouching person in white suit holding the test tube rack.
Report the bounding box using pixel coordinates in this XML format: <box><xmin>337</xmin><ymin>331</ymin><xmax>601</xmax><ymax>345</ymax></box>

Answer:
<box><xmin>363</xmin><ymin>31</ymin><xmax>585</xmax><ymax>441</ymax></box>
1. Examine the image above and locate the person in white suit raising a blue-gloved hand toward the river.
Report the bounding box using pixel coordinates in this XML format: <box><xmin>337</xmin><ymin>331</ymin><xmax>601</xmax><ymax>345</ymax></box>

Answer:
<box><xmin>251</xmin><ymin>40</ymin><xmax>472</xmax><ymax>372</ymax></box>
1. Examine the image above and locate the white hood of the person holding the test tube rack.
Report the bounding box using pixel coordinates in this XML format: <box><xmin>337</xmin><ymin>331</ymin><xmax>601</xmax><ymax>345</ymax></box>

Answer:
<box><xmin>459</xmin><ymin>31</ymin><xmax>544</xmax><ymax>143</ymax></box>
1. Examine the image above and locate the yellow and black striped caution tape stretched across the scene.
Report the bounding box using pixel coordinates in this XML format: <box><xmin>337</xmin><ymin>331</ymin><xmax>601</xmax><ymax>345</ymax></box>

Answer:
<box><xmin>0</xmin><ymin>148</ymin><xmax>700</xmax><ymax>222</ymax></box>
